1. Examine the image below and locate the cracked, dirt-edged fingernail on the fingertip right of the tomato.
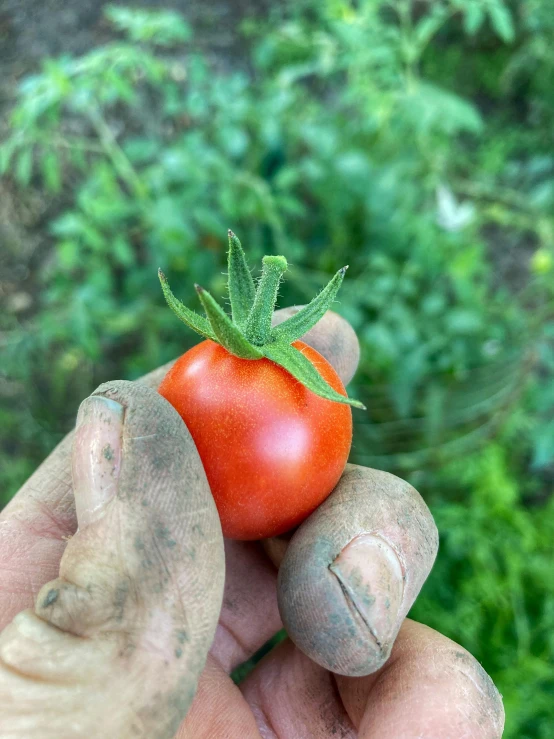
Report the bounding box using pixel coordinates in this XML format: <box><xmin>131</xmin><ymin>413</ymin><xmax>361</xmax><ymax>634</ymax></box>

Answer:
<box><xmin>330</xmin><ymin>534</ymin><xmax>404</xmax><ymax>651</ymax></box>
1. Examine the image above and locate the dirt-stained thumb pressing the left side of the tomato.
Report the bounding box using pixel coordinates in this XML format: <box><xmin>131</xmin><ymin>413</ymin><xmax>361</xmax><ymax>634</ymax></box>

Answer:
<box><xmin>0</xmin><ymin>382</ymin><xmax>224</xmax><ymax>739</ymax></box>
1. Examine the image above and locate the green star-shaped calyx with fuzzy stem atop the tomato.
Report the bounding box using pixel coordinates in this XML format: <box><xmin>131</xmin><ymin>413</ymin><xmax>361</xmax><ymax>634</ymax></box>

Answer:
<box><xmin>158</xmin><ymin>231</ymin><xmax>365</xmax><ymax>409</ymax></box>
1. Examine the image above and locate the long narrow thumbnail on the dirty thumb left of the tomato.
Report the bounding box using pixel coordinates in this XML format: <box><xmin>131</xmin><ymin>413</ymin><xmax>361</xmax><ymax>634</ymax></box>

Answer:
<box><xmin>72</xmin><ymin>395</ymin><xmax>124</xmax><ymax>529</ymax></box>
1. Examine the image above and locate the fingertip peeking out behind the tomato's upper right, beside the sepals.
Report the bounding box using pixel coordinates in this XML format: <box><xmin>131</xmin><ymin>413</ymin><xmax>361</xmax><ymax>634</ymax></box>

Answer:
<box><xmin>272</xmin><ymin>305</ymin><xmax>360</xmax><ymax>385</ymax></box>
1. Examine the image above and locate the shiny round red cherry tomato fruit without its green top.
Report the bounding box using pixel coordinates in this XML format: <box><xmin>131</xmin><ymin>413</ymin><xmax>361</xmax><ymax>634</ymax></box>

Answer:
<box><xmin>158</xmin><ymin>340</ymin><xmax>352</xmax><ymax>540</ymax></box>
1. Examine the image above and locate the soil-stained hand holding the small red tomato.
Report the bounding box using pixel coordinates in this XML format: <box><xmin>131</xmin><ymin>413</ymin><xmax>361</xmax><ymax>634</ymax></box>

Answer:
<box><xmin>0</xmin><ymin>314</ymin><xmax>503</xmax><ymax>739</ymax></box>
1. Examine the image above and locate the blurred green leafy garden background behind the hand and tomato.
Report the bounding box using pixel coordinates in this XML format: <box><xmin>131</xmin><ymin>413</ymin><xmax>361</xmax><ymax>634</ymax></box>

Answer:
<box><xmin>0</xmin><ymin>0</ymin><xmax>554</xmax><ymax>739</ymax></box>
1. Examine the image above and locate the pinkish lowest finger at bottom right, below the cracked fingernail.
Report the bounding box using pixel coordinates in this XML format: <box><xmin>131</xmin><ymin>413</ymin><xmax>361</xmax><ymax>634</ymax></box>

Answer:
<box><xmin>336</xmin><ymin>619</ymin><xmax>504</xmax><ymax>739</ymax></box>
